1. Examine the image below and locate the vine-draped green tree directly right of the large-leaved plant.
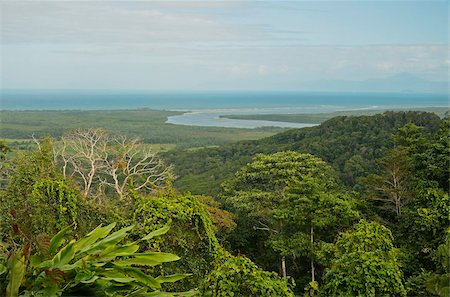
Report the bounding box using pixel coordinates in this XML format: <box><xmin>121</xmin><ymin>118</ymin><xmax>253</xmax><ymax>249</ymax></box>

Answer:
<box><xmin>132</xmin><ymin>188</ymin><xmax>222</xmax><ymax>290</ymax></box>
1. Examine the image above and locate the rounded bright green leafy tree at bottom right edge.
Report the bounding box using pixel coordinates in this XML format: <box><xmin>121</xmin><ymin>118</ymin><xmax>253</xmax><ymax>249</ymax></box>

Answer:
<box><xmin>323</xmin><ymin>220</ymin><xmax>406</xmax><ymax>297</ymax></box>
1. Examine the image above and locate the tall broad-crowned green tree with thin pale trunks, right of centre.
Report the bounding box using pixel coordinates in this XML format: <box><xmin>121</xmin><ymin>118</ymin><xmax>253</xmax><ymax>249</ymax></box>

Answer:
<box><xmin>224</xmin><ymin>151</ymin><xmax>358</xmax><ymax>282</ymax></box>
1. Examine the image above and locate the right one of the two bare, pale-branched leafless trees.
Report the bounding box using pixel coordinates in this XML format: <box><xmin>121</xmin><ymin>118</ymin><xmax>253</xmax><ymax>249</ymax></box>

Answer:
<box><xmin>105</xmin><ymin>137</ymin><xmax>172</xmax><ymax>200</ymax></box>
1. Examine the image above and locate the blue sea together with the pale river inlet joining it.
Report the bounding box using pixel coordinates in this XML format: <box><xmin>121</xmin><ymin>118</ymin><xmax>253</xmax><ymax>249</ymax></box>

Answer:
<box><xmin>0</xmin><ymin>90</ymin><xmax>449</xmax><ymax>128</ymax></box>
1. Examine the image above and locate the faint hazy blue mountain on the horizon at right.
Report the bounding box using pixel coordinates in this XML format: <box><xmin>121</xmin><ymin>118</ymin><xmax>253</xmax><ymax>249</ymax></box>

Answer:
<box><xmin>303</xmin><ymin>73</ymin><xmax>449</xmax><ymax>93</ymax></box>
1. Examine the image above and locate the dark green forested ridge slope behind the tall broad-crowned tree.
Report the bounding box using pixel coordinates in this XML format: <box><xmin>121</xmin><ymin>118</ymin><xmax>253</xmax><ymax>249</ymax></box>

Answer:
<box><xmin>163</xmin><ymin>112</ymin><xmax>440</xmax><ymax>194</ymax></box>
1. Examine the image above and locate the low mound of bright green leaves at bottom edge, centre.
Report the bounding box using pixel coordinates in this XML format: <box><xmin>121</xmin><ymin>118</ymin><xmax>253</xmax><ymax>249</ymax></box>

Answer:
<box><xmin>200</xmin><ymin>255</ymin><xmax>294</xmax><ymax>297</ymax></box>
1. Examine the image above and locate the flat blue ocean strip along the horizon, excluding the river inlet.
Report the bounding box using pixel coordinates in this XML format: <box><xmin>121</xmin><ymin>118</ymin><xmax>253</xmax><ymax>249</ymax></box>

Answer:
<box><xmin>0</xmin><ymin>90</ymin><xmax>449</xmax><ymax>111</ymax></box>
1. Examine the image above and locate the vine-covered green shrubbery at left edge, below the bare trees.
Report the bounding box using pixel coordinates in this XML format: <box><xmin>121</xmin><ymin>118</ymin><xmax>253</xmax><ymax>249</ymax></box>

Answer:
<box><xmin>0</xmin><ymin>171</ymin><xmax>113</xmax><ymax>244</ymax></box>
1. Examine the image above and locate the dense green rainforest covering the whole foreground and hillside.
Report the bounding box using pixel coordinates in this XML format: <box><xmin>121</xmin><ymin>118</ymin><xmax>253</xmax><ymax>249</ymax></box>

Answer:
<box><xmin>0</xmin><ymin>112</ymin><xmax>450</xmax><ymax>296</ymax></box>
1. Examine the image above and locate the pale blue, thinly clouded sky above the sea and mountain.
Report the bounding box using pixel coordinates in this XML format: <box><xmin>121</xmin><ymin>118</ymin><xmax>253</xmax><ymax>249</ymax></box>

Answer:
<box><xmin>0</xmin><ymin>0</ymin><xmax>450</xmax><ymax>90</ymax></box>
